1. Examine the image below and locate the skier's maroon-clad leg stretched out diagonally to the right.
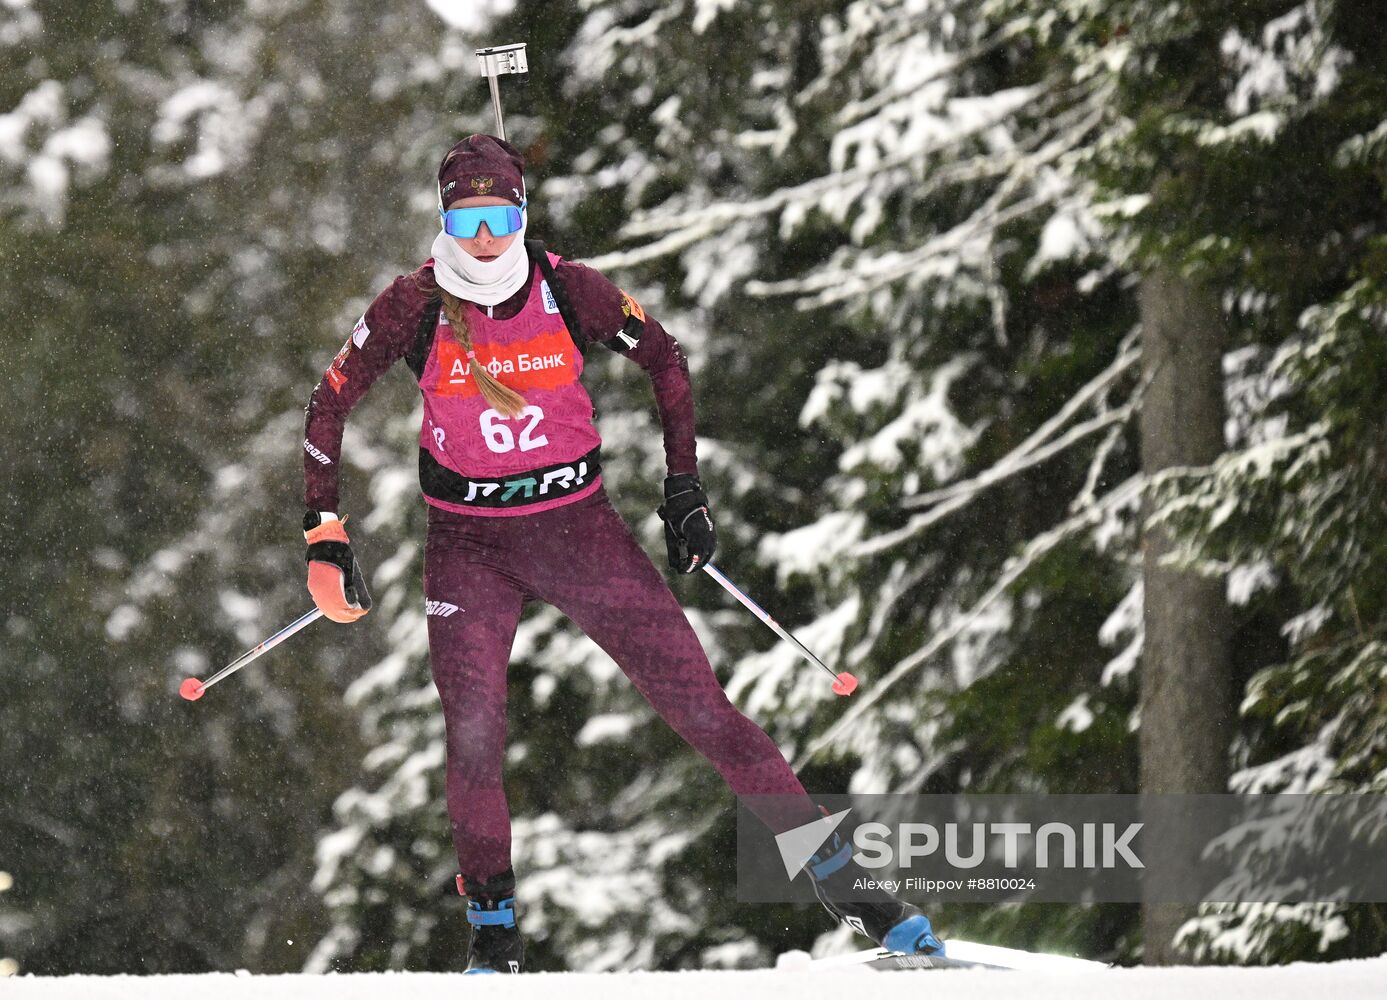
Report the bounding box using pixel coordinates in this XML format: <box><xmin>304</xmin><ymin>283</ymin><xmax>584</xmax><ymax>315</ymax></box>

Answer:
<box><xmin>535</xmin><ymin>491</ymin><xmax>820</xmax><ymax>832</ymax></box>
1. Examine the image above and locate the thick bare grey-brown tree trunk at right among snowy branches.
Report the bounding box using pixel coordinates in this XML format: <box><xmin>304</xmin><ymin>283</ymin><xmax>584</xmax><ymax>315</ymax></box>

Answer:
<box><xmin>1139</xmin><ymin>266</ymin><xmax>1233</xmax><ymax>965</ymax></box>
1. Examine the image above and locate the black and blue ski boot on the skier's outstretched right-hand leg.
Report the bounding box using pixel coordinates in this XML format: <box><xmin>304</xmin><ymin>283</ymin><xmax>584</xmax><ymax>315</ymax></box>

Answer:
<box><xmin>804</xmin><ymin>810</ymin><xmax>945</xmax><ymax>958</ymax></box>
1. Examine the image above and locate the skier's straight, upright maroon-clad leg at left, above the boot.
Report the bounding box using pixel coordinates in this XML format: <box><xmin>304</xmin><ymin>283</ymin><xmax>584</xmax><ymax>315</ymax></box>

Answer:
<box><xmin>424</xmin><ymin>509</ymin><xmax>524</xmax><ymax>881</ymax></box>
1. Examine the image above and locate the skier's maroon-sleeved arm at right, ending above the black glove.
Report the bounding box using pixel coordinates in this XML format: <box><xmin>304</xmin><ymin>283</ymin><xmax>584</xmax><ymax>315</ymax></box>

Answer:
<box><xmin>558</xmin><ymin>261</ymin><xmax>698</xmax><ymax>476</ymax></box>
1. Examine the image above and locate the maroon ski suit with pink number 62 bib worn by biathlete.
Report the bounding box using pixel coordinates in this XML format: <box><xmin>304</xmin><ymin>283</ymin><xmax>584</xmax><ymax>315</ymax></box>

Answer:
<box><xmin>304</xmin><ymin>255</ymin><xmax>818</xmax><ymax>881</ymax></box>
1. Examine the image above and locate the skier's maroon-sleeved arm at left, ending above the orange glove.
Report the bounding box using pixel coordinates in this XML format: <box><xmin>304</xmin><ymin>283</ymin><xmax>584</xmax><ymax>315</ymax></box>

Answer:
<box><xmin>304</xmin><ymin>275</ymin><xmax>424</xmax><ymax>512</ymax></box>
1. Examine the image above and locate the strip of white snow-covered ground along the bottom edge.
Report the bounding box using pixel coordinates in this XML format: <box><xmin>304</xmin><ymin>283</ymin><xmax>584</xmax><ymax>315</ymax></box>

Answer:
<box><xmin>0</xmin><ymin>956</ymin><xmax>1387</xmax><ymax>1000</ymax></box>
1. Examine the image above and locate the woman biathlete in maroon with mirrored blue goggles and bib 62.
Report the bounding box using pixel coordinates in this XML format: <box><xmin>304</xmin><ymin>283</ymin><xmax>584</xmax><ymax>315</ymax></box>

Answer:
<box><xmin>304</xmin><ymin>135</ymin><xmax>943</xmax><ymax>972</ymax></box>
